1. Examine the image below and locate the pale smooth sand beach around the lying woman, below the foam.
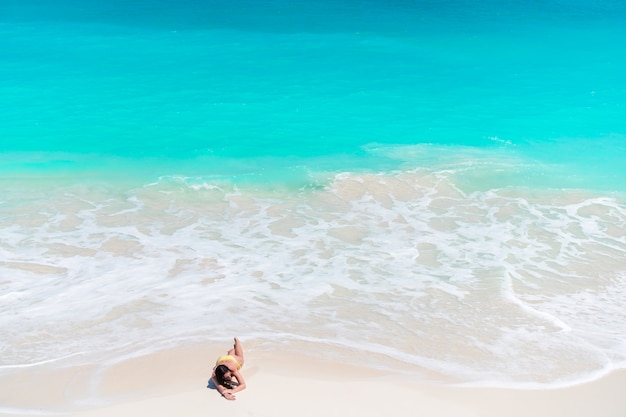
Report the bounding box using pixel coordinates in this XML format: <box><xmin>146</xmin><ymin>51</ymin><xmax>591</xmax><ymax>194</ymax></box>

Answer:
<box><xmin>0</xmin><ymin>347</ymin><xmax>626</xmax><ymax>417</ymax></box>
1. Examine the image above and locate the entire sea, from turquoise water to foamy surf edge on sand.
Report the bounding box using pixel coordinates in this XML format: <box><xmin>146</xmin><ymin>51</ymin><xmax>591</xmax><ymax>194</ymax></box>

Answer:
<box><xmin>0</xmin><ymin>0</ymin><xmax>626</xmax><ymax>404</ymax></box>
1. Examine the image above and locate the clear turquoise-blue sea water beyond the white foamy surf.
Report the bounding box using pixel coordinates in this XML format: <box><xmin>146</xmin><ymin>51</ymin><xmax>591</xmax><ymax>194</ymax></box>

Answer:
<box><xmin>0</xmin><ymin>0</ymin><xmax>626</xmax><ymax>191</ymax></box>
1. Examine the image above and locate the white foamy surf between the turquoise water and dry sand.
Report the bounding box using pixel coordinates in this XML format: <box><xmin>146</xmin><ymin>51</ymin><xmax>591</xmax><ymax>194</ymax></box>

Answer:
<box><xmin>0</xmin><ymin>170</ymin><xmax>626</xmax><ymax>385</ymax></box>
